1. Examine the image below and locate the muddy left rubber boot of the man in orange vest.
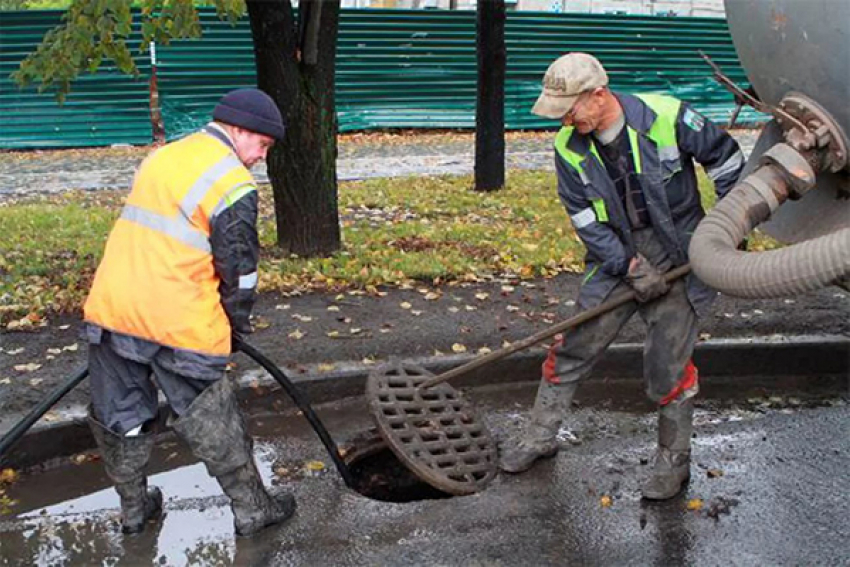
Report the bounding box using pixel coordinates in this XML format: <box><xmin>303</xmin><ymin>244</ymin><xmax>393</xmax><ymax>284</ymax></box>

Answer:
<box><xmin>89</xmin><ymin>412</ymin><xmax>162</xmax><ymax>534</ymax></box>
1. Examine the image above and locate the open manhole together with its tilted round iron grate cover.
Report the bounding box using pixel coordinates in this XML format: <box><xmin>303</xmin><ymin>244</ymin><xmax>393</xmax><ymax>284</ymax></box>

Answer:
<box><xmin>346</xmin><ymin>361</ymin><xmax>497</xmax><ymax>502</ymax></box>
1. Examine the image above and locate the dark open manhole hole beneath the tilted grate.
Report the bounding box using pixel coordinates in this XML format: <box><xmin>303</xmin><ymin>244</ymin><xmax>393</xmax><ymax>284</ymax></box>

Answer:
<box><xmin>341</xmin><ymin>428</ymin><xmax>453</xmax><ymax>503</ymax></box>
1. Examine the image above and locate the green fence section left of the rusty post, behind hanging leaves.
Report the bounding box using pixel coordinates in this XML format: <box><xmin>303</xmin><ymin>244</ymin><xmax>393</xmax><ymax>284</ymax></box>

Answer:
<box><xmin>0</xmin><ymin>11</ymin><xmax>152</xmax><ymax>148</ymax></box>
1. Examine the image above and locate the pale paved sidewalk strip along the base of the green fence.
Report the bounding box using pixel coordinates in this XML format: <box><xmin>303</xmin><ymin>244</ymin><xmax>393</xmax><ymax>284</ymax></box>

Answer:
<box><xmin>0</xmin><ymin>130</ymin><xmax>757</xmax><ymax>200</ymax></box>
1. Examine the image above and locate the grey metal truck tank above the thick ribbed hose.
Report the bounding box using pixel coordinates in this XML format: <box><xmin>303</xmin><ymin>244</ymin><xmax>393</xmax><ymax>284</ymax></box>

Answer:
<box><xmin>725</xmin><ymin>0</ymin><xmax>850</xmax><ymax>243</ymax></box>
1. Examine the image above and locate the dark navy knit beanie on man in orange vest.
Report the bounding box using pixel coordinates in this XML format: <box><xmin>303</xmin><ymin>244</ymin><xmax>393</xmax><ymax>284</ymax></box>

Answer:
<box><xmin>213</xmin><ymin>89</ymin><xmax>284</xmax><ymax>140</ymax></box>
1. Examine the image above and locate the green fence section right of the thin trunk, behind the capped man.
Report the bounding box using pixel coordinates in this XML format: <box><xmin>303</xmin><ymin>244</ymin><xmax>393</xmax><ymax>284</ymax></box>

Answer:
<box><xmin>506</xmin><ymin>13</ymin><xmax>757</xmax><ymax>128</ymax></box>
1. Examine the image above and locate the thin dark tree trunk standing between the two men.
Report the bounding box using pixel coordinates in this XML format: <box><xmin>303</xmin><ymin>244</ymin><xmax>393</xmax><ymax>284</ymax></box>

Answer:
<box><xmin>475</xmin><ymin>0</ymin><xmax>507</xmax><ymax>191</ymax></box>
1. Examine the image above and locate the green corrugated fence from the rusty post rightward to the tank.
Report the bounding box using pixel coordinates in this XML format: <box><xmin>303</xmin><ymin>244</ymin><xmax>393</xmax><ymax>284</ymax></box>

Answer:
<box><xmin>159</xmin><ymin>10</ymin><xmax>759</xmax><ymax>138</ymax></box>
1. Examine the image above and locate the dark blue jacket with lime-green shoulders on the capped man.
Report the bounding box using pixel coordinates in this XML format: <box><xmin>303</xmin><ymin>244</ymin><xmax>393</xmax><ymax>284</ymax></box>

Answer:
<box><xmin>555</xmin><ymin>93</ymin><xmax>744</xmax><ymax>313</ymax></box>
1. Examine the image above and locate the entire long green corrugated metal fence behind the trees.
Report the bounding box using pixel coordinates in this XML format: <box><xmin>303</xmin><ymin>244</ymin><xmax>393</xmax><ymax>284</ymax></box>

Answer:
<box><xmin>0</xmin><ymin>9</ymin><xmax>756</xmax><ymax>147</ymax></box>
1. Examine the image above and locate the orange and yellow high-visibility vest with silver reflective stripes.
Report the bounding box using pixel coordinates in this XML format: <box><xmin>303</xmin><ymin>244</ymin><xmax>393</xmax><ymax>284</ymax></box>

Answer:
<box><xmin>84</xmin><ymin>132</ymin><xmax>256</xmax><ymax>356</ymax></box>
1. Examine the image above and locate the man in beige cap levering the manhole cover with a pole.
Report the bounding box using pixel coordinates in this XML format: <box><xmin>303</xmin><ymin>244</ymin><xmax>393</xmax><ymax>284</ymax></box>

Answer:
<box><xmin>501</xmin><ymin>53</ymin><xmax>745</xmax><ymax>500</ymax></box>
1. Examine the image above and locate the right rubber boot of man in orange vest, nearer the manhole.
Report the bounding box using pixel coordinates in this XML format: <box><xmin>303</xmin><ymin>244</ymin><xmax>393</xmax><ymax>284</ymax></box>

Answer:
<box><xmin>171</xmin><ymin>378</ymin><xmax>295</xmax><ymax>536</ymax></box>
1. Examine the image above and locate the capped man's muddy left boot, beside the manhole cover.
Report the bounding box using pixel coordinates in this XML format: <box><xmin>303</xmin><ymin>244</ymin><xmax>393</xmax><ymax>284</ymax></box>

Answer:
<box><xmin>499</xmin><ymin>379</ymin><xmax>576</xmax><ymax>474</ymax></box>
